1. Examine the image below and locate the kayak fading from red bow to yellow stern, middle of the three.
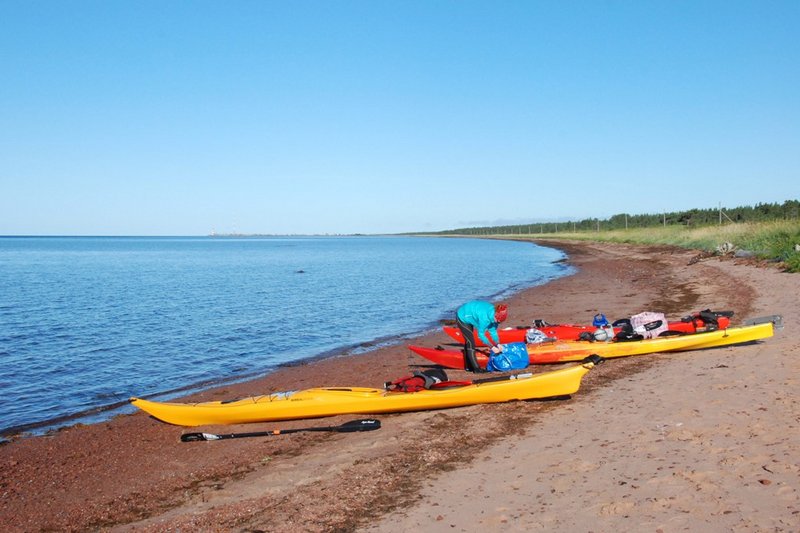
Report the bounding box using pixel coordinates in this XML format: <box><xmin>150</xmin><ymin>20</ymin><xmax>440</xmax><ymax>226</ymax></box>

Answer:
<box><xmin>409</xmin><ymin>322</ymin><xmax>773</xmax><ymax>369</ymax></box>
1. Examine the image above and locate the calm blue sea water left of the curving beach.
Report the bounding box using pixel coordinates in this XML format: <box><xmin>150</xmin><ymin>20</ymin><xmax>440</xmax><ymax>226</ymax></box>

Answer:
<box><xmin>0</xmin><ymin>237</ymin><xmax>570</xmax><ymax>435</ymax></box>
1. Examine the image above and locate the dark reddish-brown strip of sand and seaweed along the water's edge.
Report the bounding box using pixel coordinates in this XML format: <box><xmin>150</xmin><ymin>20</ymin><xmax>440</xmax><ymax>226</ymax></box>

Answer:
<box><xmin>0</xmin><ymin>241</ymin><xmax>797</xmax><ymax>531</ymax></box>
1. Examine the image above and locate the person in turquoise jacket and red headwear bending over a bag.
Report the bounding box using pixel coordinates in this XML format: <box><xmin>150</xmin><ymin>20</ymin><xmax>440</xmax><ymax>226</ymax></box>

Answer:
<box><xmin>456</xmin><ymin>300</ymin><xmax>508</xmax><ymax>372</ymax></box>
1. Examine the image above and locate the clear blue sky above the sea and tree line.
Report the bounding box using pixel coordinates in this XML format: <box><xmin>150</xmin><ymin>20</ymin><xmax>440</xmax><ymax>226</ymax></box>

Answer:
<box><xmin>0</xmin><ymin>0</ymin><xmax>800</xmax><ymax>235</ymax></box>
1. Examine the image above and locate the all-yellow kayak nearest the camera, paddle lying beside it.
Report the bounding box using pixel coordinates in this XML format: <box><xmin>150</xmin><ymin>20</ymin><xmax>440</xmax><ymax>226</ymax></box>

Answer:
<box><xmin>130</xmin><ymin>362</ymin><xmax>594</xmax><ymax>426</ymax></box>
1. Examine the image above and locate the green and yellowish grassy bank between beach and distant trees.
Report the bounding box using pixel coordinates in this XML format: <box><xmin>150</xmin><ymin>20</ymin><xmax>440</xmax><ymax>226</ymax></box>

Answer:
<box><xmin>483</xmin><ymin>220</ymin><xmax>800</xmax><ymax>272</ymax></box>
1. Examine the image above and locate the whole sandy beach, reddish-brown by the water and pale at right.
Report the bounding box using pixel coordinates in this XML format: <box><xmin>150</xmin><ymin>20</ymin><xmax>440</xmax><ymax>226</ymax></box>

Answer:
<box><xmin>0</xmin><ymin>242</ymin><xmax>800</xmax><ymax>532</ymax></box>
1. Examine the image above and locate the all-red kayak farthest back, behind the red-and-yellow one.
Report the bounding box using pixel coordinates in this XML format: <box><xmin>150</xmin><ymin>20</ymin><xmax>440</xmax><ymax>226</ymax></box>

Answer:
<box><xmin>442</xmin><ymin>311</ymin><xmax>733</xmax><ymax>346</ymax></box>
